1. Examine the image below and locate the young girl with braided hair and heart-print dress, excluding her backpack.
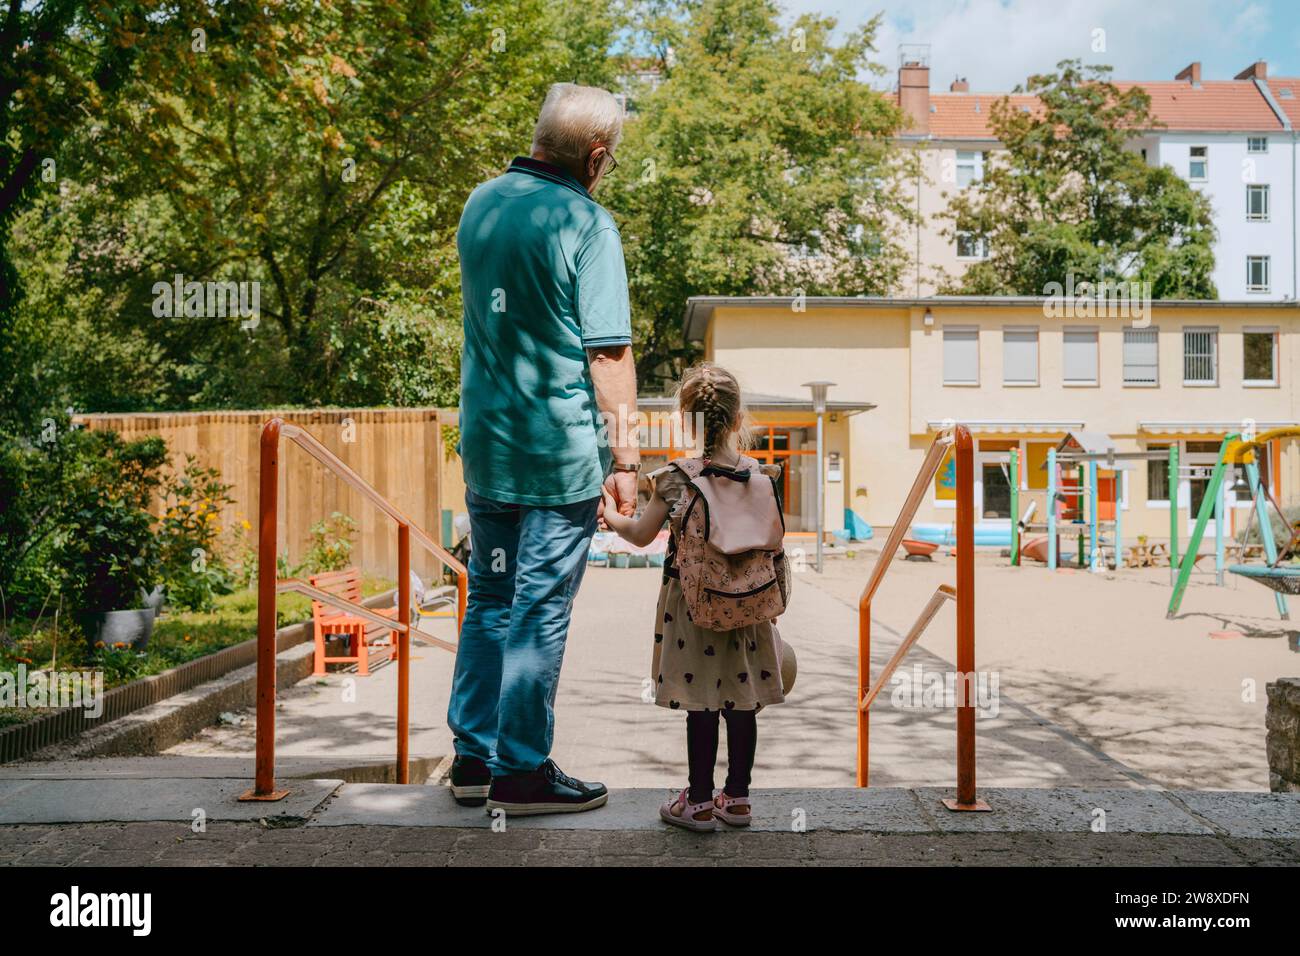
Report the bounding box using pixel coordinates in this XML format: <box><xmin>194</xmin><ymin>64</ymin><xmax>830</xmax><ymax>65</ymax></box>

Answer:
<box><xmin>605</xmin><ymin>363</ymin><xmax>785</xmax><ymax>830</ymax></box>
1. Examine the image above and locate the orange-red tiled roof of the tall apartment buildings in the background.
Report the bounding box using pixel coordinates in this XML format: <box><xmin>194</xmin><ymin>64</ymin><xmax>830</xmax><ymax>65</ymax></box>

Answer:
<box><xmin>909</xmin><ymin>78</ymin><xmax>1300</xmax><ymax>139</ymax></box>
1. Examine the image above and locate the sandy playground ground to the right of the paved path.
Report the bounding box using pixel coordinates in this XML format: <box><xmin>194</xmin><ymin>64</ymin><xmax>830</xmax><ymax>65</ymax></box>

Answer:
<box><xmin>816</xmin><ymin>555</ymin><xmax>1300</xmax><ymax>790</ymax></box>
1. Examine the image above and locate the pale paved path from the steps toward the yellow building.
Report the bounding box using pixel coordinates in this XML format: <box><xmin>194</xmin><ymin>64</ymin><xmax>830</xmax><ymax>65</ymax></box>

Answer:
<box><xmin>147</xmin><ymin>562</ymin><xmax>1144</xmax><ymax>787</ymax></box>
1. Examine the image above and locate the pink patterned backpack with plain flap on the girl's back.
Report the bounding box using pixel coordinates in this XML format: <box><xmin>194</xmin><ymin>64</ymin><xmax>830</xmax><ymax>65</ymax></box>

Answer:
<box><xmin>672</xmin><ymin>455</ymin><xmax>789</xmax><ymax>631</ymax></box>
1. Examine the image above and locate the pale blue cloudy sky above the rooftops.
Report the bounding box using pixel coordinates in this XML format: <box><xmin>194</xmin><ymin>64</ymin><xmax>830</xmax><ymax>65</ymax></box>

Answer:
<box><xmin>779</xmin><ymin>0</ymin><xmax>1300</xmax><ymax>92</ymax></box>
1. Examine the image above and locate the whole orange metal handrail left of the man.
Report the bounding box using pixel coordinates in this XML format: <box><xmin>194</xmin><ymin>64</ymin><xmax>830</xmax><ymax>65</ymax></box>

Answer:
<box><xmin>239</xmin><ymin>419</ymin><xmax>469</xmax><ymax>800</ymax></box>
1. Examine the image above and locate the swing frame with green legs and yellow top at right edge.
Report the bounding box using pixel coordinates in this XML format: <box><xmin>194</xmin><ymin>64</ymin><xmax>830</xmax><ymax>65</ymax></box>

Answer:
<box><xmin>1165</xmin><ymin>427</ymin><xmax>1300</xmax><ymax>620</ymax></box>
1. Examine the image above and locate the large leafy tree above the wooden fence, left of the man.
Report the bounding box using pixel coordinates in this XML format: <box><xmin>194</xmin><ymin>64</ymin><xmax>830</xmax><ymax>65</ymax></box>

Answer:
<box><xmin>5</xmin><ymin>0</ymin><xmax>619</xmax><ymax>408</ymax></box>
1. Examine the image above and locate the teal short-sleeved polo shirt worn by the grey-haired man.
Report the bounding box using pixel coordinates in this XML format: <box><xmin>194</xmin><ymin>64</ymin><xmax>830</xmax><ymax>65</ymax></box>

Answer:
<box><xmin>456</xmin><ymin>156</ymin><xmax>632</xmax><ymax>505</ymax></box>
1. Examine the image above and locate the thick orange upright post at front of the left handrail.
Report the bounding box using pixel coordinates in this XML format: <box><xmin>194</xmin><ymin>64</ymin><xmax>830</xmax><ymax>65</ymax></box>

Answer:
<box><xmin>239</xmin><ymin>419</ymin><xmax>289</xmax><ymax>800</ymax></box>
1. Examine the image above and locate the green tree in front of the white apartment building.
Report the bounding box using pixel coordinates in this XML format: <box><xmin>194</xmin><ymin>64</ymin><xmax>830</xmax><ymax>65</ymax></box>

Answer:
<box><xmin>943</xmin><ymin>60</ymin><xmax>1217</xmax><ymax>299</ymax></box>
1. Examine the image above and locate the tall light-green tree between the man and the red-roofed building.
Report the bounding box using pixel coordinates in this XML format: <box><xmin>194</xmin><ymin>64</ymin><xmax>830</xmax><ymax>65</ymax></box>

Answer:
<box><xmin>599</xmin><ymin>0</ymin><xmax>910</xmax><ymax>386</ymax></box>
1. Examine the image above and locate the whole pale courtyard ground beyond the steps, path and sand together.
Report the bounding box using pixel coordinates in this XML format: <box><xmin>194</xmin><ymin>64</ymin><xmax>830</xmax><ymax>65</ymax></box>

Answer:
<box><xmin>170</xmin><ymin>538</ymin><xmax>1300</xmax><ymax>790</ymax></box>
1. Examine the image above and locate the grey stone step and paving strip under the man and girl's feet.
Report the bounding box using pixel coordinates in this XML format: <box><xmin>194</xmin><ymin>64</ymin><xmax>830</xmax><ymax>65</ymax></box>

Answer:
<box><xmin>0</xmin><ymin>779</ymin><xmax>1300</xmax><ymax>866</ymax></box>
